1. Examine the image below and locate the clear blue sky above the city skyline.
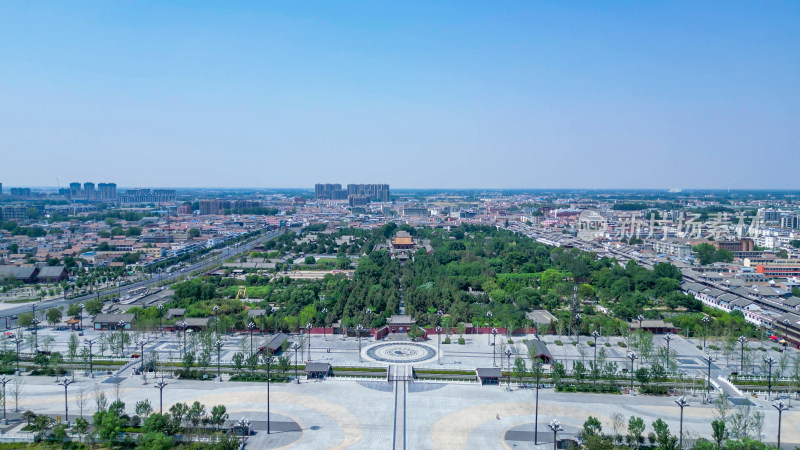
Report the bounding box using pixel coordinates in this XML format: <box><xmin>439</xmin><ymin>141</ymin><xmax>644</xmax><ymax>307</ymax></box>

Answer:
<box><xmin>0</xmin><ymin>1</ymin><xmax>800</xmax><ymax>189</ymax></box>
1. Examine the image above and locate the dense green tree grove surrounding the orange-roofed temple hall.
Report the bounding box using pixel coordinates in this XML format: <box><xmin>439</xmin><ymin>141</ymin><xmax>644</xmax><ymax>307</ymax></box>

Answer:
<box><xmin>161</xmin><ymin>223</ymin><xmax>702</xmax><ymax>333</ymax></box>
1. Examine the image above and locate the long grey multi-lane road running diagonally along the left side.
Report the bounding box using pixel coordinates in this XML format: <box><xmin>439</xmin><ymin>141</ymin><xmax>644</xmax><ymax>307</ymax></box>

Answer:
<box><xmin>0</xmin><ymin>230</ymin><xmax>284</xmax><ymax>329</ymax></box>
